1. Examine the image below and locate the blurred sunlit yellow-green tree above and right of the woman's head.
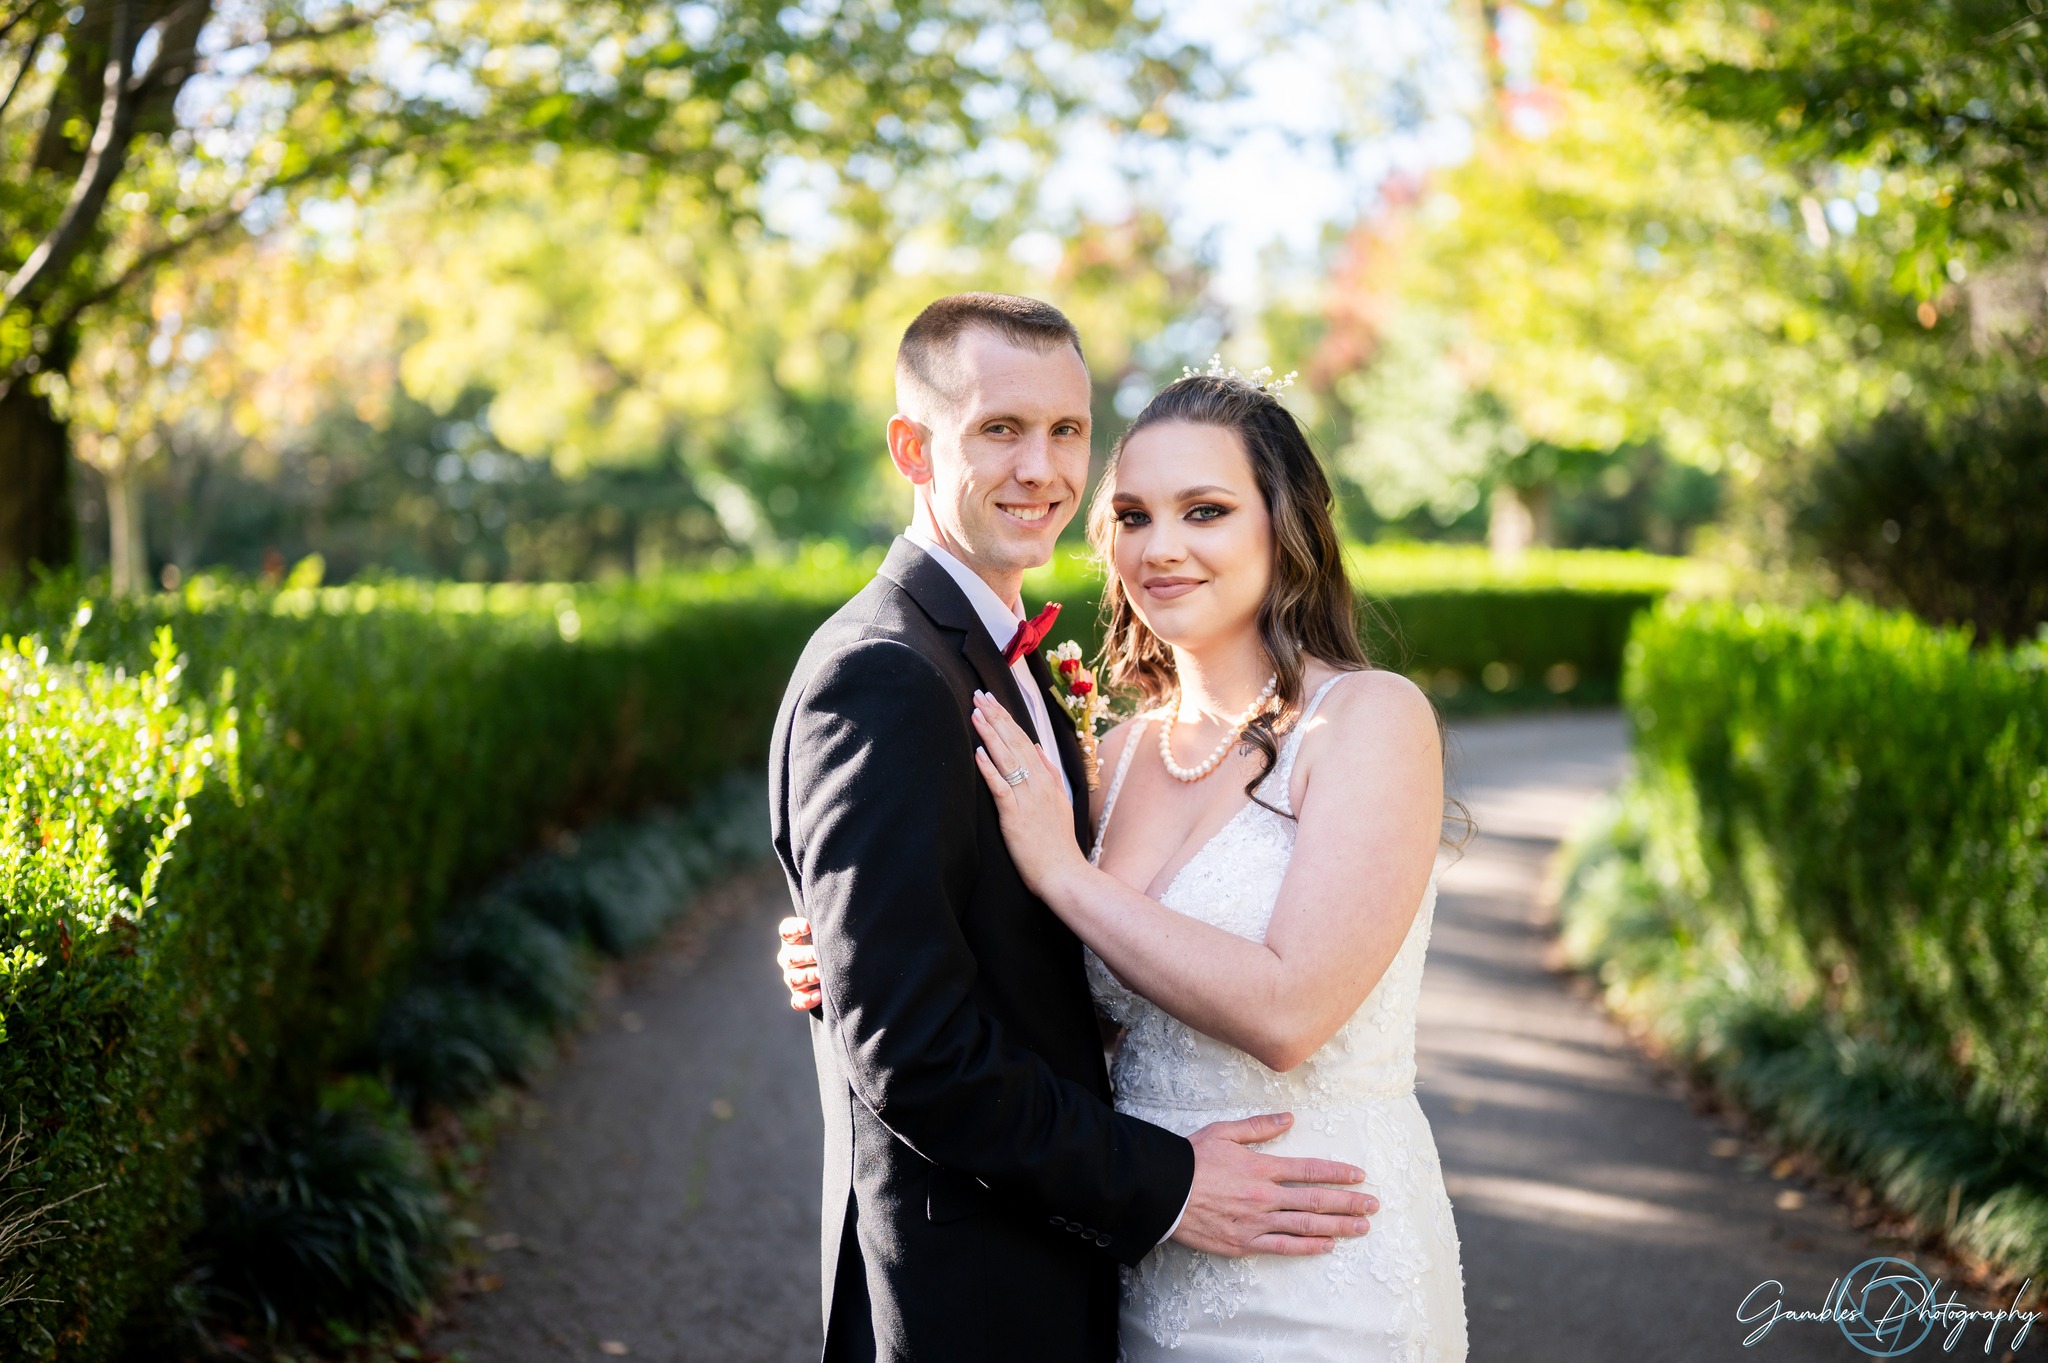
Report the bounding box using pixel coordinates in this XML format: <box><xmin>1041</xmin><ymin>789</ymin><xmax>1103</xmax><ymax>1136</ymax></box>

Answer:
<box><xmin>1335</xmin><ymin>0</ymin><xmax>1952</xmax><ymax>548</ymax></box>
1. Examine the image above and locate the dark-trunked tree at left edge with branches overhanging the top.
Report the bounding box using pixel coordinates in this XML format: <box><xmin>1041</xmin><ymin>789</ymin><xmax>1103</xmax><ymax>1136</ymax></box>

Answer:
<box><xmin>0</xmin><ymin>0</ymin><xmax>1190</xmax><ymax>571</ymax></box>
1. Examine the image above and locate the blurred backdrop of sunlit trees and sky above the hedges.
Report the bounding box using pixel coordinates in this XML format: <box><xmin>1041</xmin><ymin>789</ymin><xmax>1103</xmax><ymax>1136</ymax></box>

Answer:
<box><xmin>0</xmin><ymin>0</ymin><xmax>2048</xmax><ymax>634</ymax></box>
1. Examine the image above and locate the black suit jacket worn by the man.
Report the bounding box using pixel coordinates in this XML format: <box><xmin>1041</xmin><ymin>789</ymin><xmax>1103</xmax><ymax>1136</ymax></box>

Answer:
<box><xmin>770</xmin><ymin>540</ymin><xmax>1194</xmax><ymax>1363</ymax></box>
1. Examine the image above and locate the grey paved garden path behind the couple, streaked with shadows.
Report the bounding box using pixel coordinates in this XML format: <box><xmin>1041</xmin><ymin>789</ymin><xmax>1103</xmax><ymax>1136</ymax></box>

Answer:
<box><xmin>434</xmin><ymin>714</ymin><xmax>1900</xmax><ymax>1363</ymax></box>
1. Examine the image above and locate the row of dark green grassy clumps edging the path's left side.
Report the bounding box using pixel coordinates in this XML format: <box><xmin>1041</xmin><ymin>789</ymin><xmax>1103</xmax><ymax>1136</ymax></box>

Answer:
<box><xmin>214</xmin><ymin>774</ymin><xmax>768</xmax><ymax>1340</ymax></box>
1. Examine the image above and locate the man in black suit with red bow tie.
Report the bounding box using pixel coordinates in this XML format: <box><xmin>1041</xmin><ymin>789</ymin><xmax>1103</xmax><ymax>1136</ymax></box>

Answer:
<box><xmin>768</xmin><ymin>295</ymin><xmax>1376</xmax><ymax>1363</ymax></box>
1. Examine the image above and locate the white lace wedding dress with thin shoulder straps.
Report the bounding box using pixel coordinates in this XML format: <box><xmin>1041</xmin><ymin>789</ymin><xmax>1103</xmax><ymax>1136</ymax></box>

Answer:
<box><xmin>1087</xmin><ymin>677</ymin><xmax>1464</xmax><ymax>1363</ymax></box>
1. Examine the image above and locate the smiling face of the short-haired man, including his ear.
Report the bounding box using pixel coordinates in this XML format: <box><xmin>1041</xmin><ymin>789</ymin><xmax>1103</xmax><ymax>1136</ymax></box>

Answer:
<box><xmin>889</xmin><ymin>329</ymin><xmax>1090</xmax><ymax>573</ymax></box>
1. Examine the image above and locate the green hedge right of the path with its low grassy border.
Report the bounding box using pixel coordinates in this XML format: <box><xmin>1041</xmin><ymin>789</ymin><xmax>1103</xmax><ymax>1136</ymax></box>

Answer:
<box><xmin>1565</xmin><ymin>604</ymin><xmax>2048</xmax><ymax>1269</ymax></box>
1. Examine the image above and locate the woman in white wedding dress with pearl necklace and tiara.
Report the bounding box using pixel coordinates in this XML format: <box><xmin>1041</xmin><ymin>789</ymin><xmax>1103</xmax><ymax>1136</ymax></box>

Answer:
<box><xmin>975</xmin><ymin>375</ymin><xmax>1466</xmax><ymax>1363</ymax></box>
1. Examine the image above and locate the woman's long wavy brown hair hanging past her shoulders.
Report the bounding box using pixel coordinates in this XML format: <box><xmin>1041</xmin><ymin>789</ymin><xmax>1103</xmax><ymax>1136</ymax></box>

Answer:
<box><xmin>1087</xmin><ymin>375</ymin><xmax>1372</xmax><ymax>812</ymax></box>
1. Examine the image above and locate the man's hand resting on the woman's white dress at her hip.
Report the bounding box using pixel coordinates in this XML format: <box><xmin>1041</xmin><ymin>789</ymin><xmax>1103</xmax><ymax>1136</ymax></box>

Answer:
<box><xmin>1174</xmin><ymin>1113</ymin><xmax>1380</xmax><ymax>1259</ymax></box>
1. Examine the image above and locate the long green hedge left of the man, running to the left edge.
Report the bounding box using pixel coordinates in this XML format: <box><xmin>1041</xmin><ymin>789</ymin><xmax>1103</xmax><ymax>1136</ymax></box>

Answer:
<box><xmin>0</xmin><ymin>561</ymin><xmax>864</xmax><ymax>1359</ymax></box>
